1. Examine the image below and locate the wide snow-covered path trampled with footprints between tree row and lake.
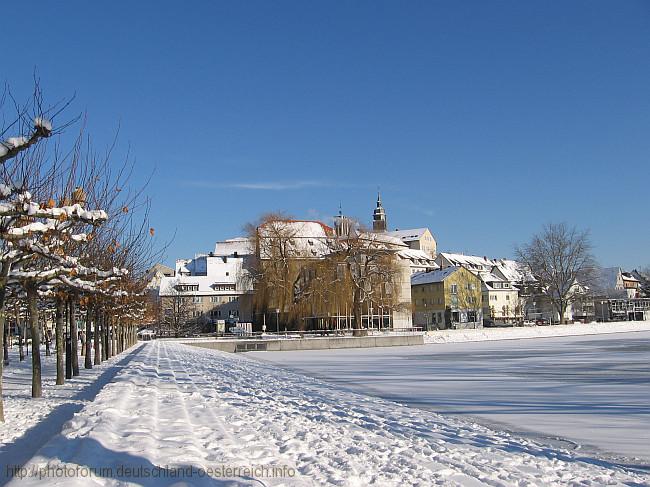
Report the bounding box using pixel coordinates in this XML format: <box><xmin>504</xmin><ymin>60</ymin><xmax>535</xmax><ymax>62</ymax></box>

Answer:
<box><xmin>6</xmin><ymin>342</ymin><xmax>650</xmax><ymax>486</ymax></box>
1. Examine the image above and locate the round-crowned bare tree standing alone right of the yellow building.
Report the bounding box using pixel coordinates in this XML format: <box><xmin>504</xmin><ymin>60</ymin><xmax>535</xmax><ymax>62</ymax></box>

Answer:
<box><xmin>515</xmin><ymin>223</ymin><xmax>597</xmax><ymax>323</ymax></box>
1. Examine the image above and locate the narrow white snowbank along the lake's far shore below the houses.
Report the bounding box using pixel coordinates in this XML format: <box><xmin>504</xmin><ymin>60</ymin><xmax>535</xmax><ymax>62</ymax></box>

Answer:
<box><xmin>424</xmin><ymin>321</ymin><xmax>650</xmax><ymax>343</ymax></box>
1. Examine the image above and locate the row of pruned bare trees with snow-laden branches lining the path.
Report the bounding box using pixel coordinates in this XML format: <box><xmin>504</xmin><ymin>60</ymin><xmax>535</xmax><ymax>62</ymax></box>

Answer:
<box><xmin>0</xmin><ymin>81</ymin><xmax>155</xmax><ymax>421</ymax></box>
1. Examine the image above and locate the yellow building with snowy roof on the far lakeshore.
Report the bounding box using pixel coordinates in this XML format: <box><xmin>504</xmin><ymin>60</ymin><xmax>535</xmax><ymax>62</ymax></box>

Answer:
<box><xmin>411</xmin><ymin>267</ymin><xmax>483</xmax><ymax>330</ymax></box>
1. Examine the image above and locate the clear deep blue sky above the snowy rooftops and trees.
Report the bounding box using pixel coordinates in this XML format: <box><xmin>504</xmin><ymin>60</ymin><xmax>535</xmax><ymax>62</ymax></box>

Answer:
<box><xmin>0</xmin><ymin>0</ymin><xmax>650</xmax><ymax>268</ymax></box>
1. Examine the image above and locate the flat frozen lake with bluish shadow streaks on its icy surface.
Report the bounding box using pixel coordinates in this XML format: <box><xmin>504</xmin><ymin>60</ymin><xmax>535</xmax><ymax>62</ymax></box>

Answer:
<box><xmin>247</xmin><ymin>332</ymin><xmax>650</xmax><ymax>465</ymax></box>
